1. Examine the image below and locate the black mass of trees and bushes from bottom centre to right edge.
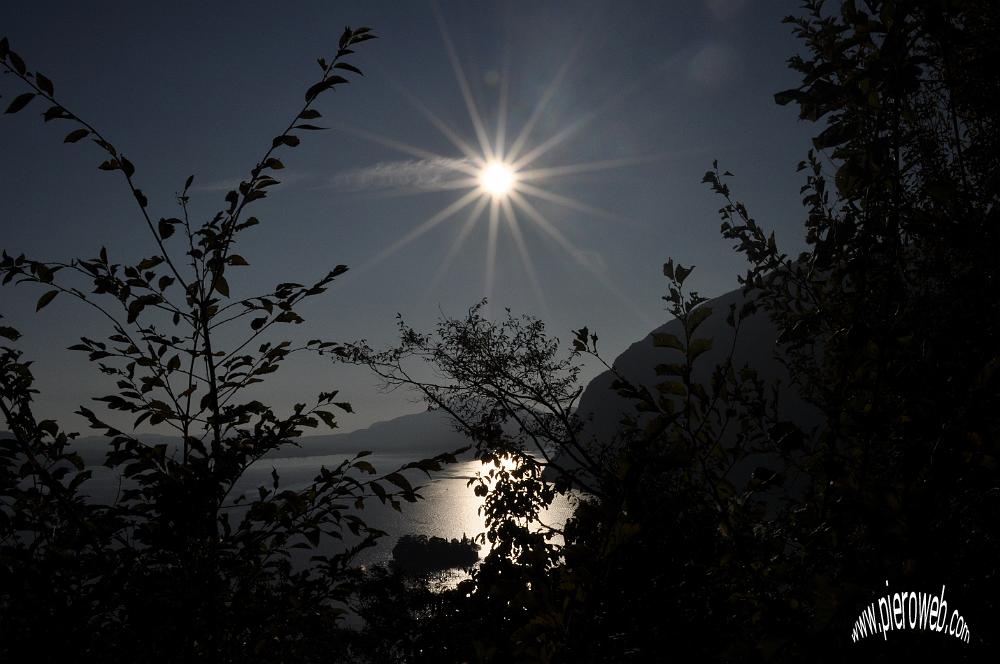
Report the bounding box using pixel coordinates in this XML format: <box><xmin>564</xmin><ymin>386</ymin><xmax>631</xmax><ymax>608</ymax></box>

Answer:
<box><xmin>353</xmin><ymin>0</ymin><xmax>1000</xmax><ymax>662</ymax></box>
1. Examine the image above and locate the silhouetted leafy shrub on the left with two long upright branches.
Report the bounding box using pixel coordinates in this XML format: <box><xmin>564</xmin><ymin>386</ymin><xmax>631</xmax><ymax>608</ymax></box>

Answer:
<box><xmin>0</xmin><ymin>28</ymin><xmax>464</xmax><ymax>661</ymax></box>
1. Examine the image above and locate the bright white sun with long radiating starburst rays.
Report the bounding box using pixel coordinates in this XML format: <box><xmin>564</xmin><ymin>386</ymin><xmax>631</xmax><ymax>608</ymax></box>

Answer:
<box><xmin>342</xmin><ymin>7</ymin><xmax>660</xmax><ymax>319</ymax></box>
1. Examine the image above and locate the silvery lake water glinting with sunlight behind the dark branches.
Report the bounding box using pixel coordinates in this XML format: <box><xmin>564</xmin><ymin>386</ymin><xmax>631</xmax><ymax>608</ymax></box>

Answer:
<box><xmin>82</xmin><ymin>455</ymin><xmax>574</xmax><ymax>565</ymax></box>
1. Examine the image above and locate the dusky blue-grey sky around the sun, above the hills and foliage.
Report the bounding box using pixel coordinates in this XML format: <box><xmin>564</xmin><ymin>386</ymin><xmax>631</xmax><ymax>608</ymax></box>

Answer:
<box><xmin>0</xmin><ymin>0</ymin><xmax>812</xmax><ymax>430</ymax></box>
